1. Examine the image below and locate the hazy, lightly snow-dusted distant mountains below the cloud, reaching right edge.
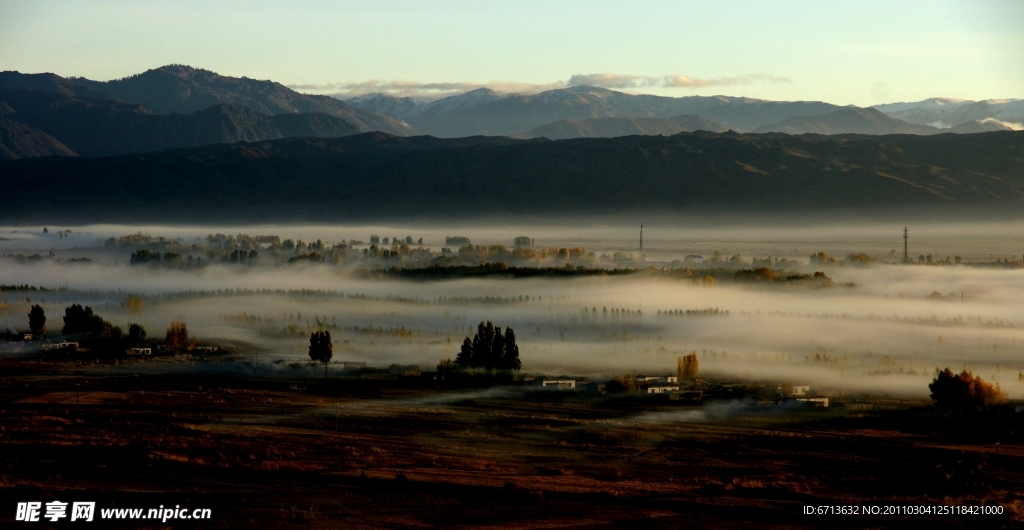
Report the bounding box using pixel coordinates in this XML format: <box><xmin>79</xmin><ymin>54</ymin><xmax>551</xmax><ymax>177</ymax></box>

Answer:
<box><xmin>347</xmin><ymin>86</ymin><xmax>1024</xmax><ymax>139</ymax></box>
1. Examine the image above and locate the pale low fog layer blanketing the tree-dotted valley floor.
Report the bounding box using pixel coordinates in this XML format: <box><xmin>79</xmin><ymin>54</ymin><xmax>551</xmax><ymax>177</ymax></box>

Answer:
<box><xmin>6</xmin><ymin>222</ymin><xmax>1024</xmax><ymax>398</ymax></box>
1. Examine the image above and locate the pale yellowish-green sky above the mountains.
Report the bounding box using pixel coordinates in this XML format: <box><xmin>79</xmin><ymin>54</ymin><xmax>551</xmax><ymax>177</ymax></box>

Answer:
<box><xmin>0</xmin><ymin>0</ymin><xmax>1024</xmax><ymax>106</ymax></box>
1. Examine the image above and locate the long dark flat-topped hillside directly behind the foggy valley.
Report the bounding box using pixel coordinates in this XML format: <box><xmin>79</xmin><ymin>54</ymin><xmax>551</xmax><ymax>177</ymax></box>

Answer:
<box><xmin>0</xmin><ymin>132</ymin><xmax>1024</xmax><ymax>222</ymax></box>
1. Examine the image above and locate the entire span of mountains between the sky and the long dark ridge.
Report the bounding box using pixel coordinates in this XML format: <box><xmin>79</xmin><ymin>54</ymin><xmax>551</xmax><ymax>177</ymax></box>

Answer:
<box><xmin>0</xmin><ymin>64</ymin><xmax>1024</xmax><ymax>159</ymax></box>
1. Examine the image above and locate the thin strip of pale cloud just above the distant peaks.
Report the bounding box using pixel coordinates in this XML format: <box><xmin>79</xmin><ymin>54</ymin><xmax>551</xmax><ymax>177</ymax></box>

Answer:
<box><xmin>288</xmin><ymin>74</ymin><xmax>792</xmax><ymax>100</ymax></box>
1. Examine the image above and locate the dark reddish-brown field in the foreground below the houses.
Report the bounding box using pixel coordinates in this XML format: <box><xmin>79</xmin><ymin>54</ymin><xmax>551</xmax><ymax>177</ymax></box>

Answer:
<box><xmin>0</xmin><ymin>360</ymin><xmax>1024</xmax><ymax>528</ymax></box>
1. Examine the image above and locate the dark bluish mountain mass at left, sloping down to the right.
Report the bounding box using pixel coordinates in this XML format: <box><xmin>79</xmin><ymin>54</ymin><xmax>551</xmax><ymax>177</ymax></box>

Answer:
<box><xmin>0</xmin><ymin>65</ymin><xmax>414</xmax><ymax>159</ymax></box>
